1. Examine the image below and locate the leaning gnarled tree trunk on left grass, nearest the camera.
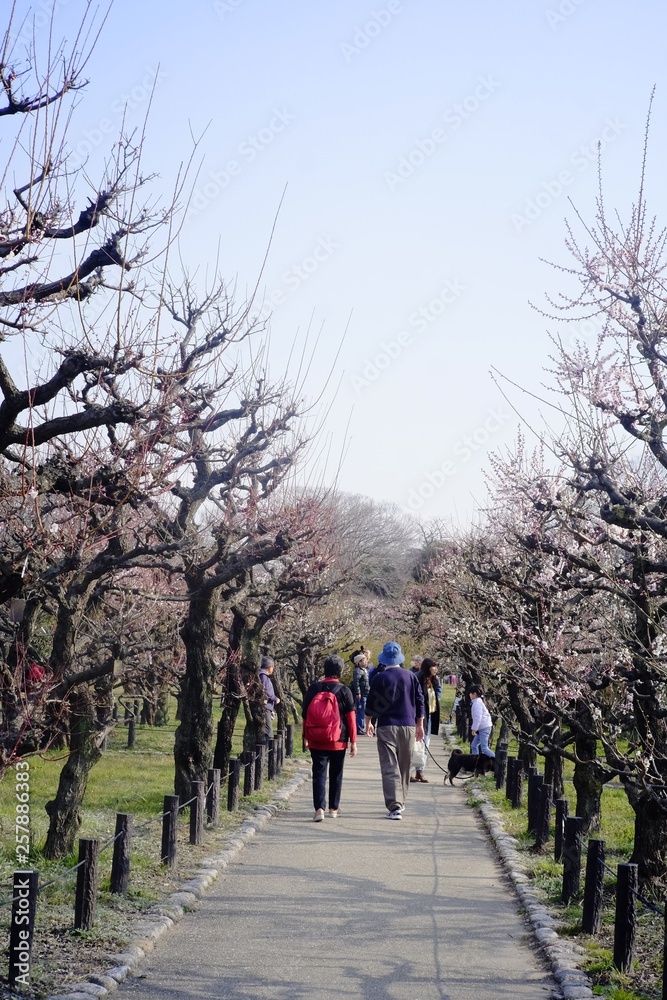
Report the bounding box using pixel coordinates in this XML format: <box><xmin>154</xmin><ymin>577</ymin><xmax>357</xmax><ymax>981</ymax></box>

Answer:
<box><xmin>44</xmin><ymin>685</ymin><xmax>102</xmax><ymax>860</ymax></box>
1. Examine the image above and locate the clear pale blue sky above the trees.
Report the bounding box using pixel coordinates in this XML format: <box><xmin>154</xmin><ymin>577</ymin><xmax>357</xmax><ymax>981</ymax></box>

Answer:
<box><xmin>14</xmin><ymin>0</ymin><xmax>667</xmax><ymax>525</ymax></box>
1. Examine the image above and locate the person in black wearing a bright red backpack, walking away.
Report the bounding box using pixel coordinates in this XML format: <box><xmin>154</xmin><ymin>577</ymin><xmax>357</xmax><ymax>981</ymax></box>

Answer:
<box><xmin>303</xmin><ymin>655</ymin><xmax>357</xmax><ymax>823</ymax></box>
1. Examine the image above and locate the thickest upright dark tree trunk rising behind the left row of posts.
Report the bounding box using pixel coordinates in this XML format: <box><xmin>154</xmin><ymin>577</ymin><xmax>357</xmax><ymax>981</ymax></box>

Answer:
<box><xmin>174</xmin><ymin>580</ymin><xmax>216</xmax><ymax>802</ymax></box>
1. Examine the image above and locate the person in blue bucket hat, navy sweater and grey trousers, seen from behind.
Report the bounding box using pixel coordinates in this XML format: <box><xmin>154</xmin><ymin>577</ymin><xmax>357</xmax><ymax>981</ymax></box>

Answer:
<box><xmin>366</xmin><ymin>642</ymin><xmax>424</xmax><ymax>819</ymax></box>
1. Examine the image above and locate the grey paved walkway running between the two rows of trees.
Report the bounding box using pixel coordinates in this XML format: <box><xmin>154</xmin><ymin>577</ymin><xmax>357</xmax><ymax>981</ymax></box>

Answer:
<box><xmin>116</xmin><ymin>738</ymin><xmax>557</xmax><ymax>1000</ymax></box>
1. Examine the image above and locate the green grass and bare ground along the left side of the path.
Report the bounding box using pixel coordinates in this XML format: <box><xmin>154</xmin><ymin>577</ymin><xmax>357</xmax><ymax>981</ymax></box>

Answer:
<box><xmin>0</xmin><ymin>708</ymin><xmax>302</xmax><ymax>997</ymax></box>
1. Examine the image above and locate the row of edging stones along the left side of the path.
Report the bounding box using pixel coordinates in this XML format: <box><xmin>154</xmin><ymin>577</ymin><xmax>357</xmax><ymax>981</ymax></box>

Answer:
<box><xmin>47</xmin><ymin>767</ymin><xmax>311</xmax><ymax>1000</ymax></box>
